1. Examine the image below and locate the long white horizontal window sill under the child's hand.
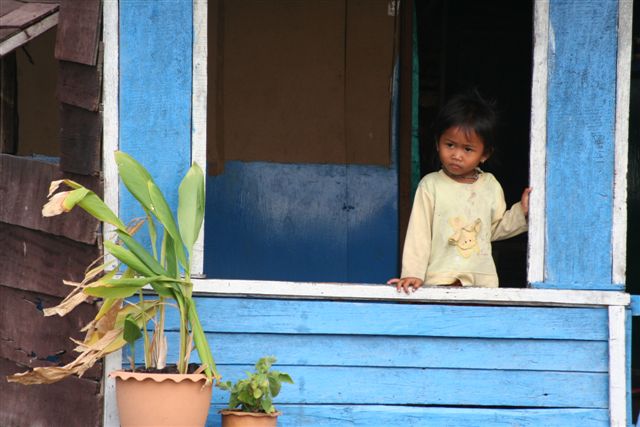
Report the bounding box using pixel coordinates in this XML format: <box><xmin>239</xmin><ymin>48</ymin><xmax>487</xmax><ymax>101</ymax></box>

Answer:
<box><xmin>193</xmin><ymin>279</ymin><xmax>631</xmax><ymax>307</ymax></box>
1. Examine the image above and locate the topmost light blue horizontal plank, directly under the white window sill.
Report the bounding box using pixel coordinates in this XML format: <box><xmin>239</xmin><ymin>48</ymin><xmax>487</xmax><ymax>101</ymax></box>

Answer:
<box><xmin>172</xmin><ymin>298</ymin><xmax>609</xmax><ymax>340</ymax></box>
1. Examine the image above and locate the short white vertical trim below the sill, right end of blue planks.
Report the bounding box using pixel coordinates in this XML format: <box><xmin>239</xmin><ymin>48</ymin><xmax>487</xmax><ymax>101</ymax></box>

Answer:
<box><xmin>609</xmin><ymin>306</ymin><xmax>627</xmax><ymax>427</ymax></box>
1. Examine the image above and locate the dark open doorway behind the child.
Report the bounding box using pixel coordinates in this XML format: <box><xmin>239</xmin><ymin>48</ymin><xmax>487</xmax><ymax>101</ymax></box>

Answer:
<box><xmin>415</xmin><ymin>0</ymin><xmax>533</xmax><ymax>287</ymax></box>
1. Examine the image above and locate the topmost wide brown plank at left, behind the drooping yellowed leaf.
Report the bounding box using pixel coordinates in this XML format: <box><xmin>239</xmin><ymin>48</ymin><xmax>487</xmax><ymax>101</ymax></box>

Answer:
<box><xmin>0</xmin><ymin>154</ymin><xmax>102</xmax><ymax>244</ymax></box>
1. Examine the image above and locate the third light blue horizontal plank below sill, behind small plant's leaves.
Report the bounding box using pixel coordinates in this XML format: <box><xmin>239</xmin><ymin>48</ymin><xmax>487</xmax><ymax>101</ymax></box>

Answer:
<box><xmin>212</xmin><ymin>364</ymin><xmax>609</xmax><ymax>409</ymax></box>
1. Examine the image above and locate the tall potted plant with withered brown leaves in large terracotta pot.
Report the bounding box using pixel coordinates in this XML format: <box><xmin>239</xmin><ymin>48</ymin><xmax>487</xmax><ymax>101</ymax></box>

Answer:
<box><xmin>8</xmin><ymin>152</ymin><xmax>219</xmax><ymax>426</ymax></box>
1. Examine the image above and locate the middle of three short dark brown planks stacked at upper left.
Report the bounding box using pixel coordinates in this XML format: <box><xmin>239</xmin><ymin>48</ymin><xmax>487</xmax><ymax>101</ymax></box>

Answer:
<box><xmin>57</xmin><ymin>55</ymin><xmax>102</xmax><ymax>111</ymax></box>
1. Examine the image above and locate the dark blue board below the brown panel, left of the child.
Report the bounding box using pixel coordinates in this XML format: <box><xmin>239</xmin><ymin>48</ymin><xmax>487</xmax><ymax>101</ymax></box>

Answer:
<box><xmin>205</xmin><ymin>161</ymin><xmax>398</xmax><ymax>283</ymax></box>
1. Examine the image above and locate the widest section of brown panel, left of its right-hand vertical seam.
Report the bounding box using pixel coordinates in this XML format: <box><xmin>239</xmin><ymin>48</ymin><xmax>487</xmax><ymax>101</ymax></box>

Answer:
<box><xmin>222</xmin><ymin>0</ymin><xmax>346</xmax><ymax>163</ymax></box>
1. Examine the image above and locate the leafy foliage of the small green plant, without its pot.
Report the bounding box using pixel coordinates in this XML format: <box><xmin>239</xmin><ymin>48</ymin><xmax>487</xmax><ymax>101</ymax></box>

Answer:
<box><xmin>218</xmin><ymin>356</ymin><xmax>293</xmax><ymax>414</ymax></box>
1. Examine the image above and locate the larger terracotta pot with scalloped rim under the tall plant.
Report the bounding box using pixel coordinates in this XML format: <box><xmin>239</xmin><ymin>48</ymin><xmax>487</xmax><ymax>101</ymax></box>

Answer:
<box><xmin>110</xmin><ymin>371</ymin><xmax>212</xmax><ymax>427</ymax></box>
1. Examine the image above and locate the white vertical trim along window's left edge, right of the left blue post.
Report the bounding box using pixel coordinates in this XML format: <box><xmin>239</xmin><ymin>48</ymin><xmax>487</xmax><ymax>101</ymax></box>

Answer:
<box><xmin>191</xmin><ymin>0</ymin><xmax>208</xmax><ymax>275</ymax></box>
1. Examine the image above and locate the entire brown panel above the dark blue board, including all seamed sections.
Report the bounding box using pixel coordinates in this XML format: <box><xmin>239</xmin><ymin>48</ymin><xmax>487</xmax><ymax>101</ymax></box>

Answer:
<box><xmin>208</xmin><ymin>0</ymin><xmax>395</xmax><ymax>166</ymax></box>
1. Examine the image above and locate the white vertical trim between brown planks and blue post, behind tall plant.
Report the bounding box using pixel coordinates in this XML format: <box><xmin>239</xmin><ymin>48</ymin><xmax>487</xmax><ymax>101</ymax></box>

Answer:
<box><xmin>102</xmin><ymin>0</ymin><xmax>122</xmax><ymax>427</ymax></box>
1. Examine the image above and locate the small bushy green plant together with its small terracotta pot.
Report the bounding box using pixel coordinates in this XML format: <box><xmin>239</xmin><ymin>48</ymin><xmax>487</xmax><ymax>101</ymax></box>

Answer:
<box><xmin>218</xmin><ymin>356</ymin><xmax>293</xmax><ymax>427</ymax></box>
